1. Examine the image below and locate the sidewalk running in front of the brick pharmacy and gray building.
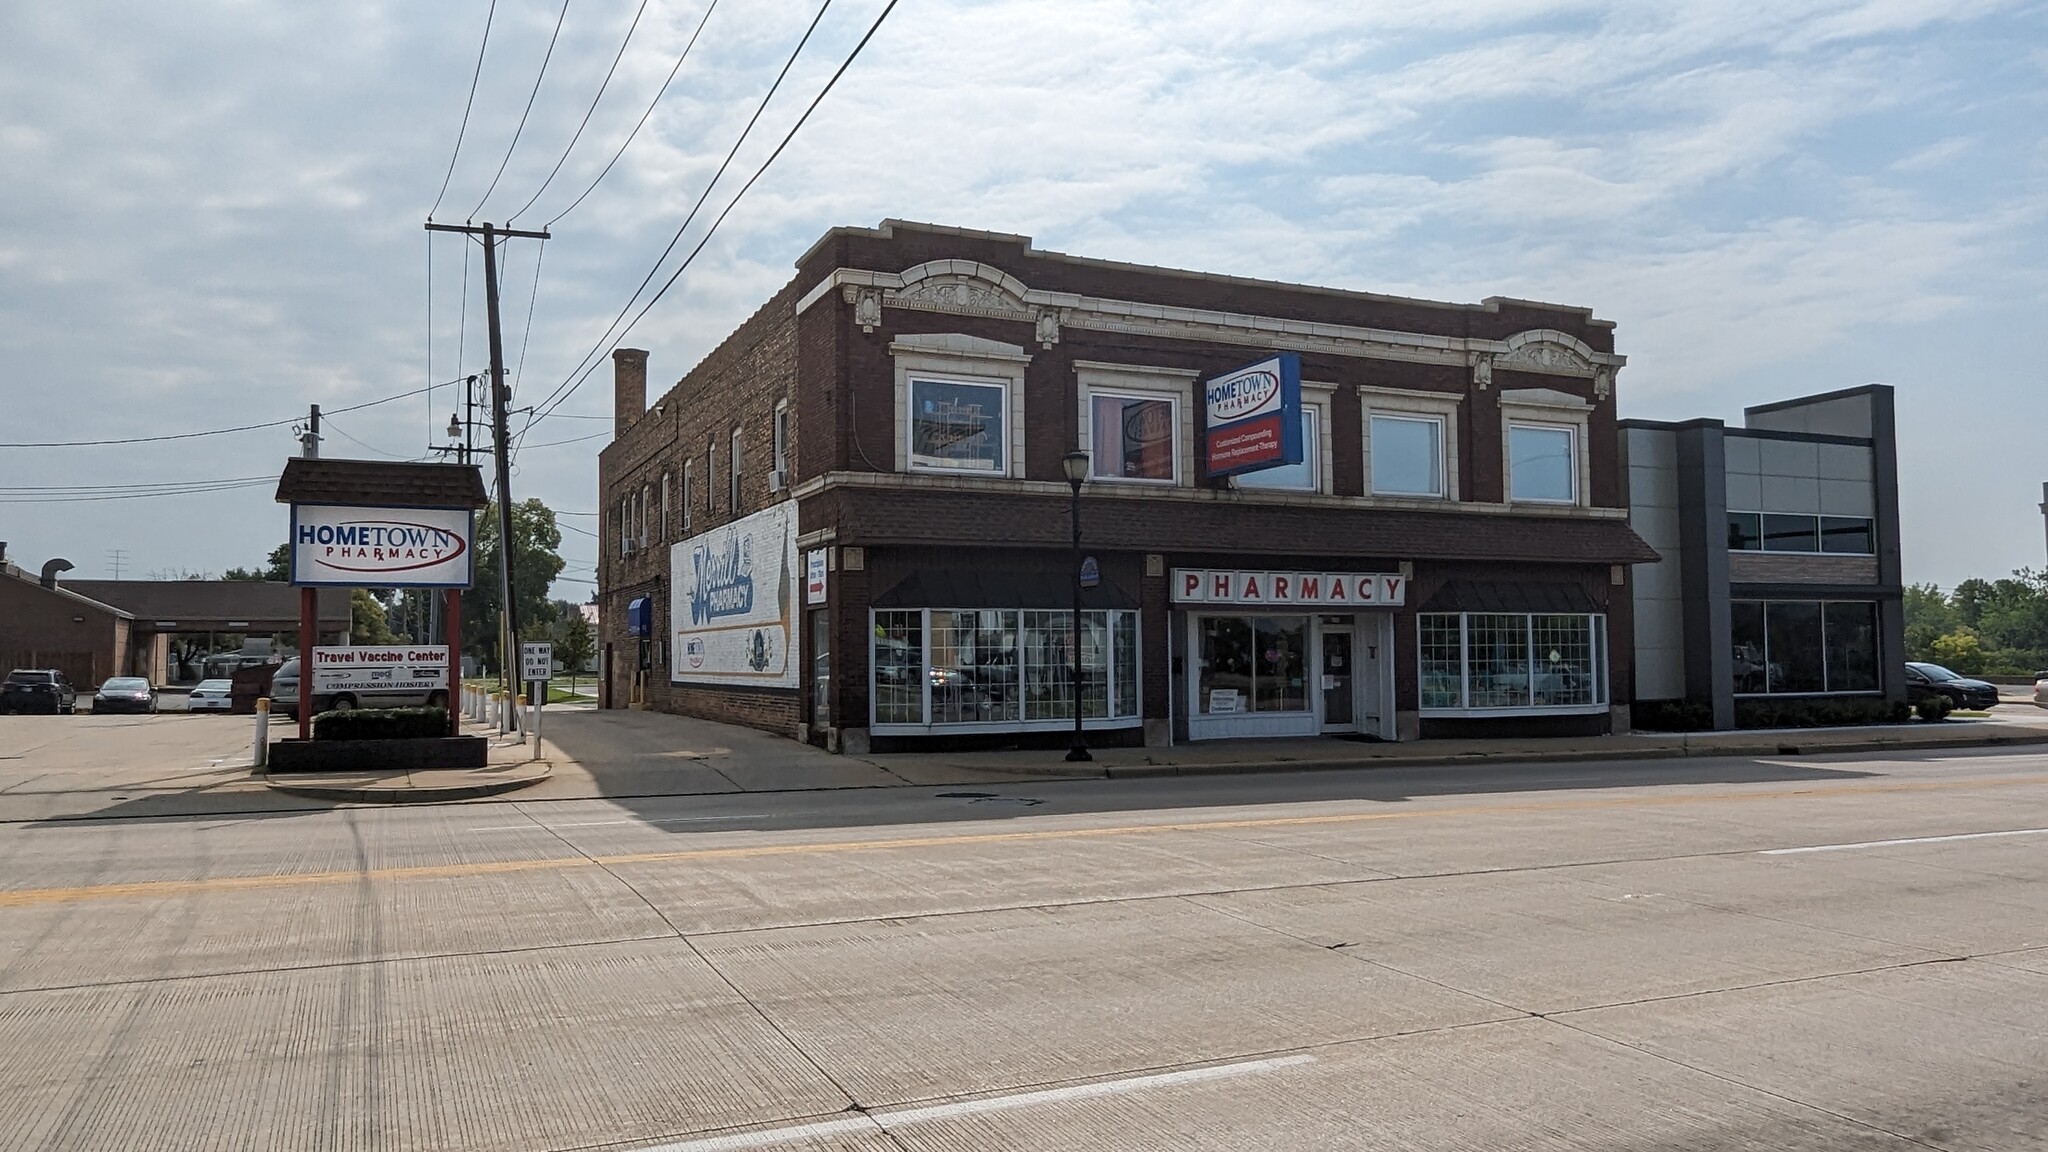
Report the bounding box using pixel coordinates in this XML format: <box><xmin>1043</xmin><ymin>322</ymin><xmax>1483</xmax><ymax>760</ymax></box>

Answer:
<box><xmin>862</xmin><ymin>709</ymin><xmax>2048</xmax><ymax>779</ymax></box>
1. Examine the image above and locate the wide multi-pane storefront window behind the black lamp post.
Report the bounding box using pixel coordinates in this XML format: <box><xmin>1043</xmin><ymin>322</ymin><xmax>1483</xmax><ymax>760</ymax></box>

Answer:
<box><xmin>874</xmin><ymin>609</ymin><xmax>1141</xmax><ymax>726</ymax></box>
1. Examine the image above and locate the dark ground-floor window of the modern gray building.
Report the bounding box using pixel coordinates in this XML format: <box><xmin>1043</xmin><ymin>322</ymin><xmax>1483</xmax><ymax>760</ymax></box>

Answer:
<box><xmin>1729</xmin><ymin>601</ymin><xmax>1878</xmax><ymax>695</ymax></box>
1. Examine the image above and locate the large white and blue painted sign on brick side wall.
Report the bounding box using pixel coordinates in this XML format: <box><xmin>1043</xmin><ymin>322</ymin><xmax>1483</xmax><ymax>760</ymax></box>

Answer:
<box><xmin>668</xmin><ymin>500</ymin><xmax>799</xmax><ymax>689</ymax></box>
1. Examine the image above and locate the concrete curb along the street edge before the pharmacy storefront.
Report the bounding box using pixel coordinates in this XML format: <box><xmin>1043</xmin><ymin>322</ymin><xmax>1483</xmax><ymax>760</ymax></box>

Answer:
<box><xmin>956</xmin><ymin>730</ymin><xmax>2048</xmax><ymax>779</ymax></box>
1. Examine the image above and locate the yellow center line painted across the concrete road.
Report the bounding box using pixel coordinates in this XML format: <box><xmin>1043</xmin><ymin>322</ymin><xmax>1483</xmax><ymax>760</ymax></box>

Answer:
<box><xmin>0</xmin><ymin>775</ymin><xmax>2048</xmax><ymax>908</ymax></box>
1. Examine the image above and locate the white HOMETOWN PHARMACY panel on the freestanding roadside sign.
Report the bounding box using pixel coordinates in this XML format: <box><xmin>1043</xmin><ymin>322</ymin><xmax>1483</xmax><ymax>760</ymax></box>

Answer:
<box><xmin>291</xmin><ymin>504</ymin><xmax>475</xmax><ymax>588</ymax></box>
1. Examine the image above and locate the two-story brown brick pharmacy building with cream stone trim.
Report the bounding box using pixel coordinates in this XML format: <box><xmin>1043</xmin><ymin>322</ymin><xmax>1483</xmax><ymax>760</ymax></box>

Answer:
<box><xmin>598</xmin><ymin>221</ymin><xmax>1657</xmax><ymax>750</ymax></box>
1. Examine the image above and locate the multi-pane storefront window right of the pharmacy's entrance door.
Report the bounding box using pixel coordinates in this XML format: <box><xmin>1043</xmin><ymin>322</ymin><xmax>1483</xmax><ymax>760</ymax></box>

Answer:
<box><xmin>1415</xmin><ymin>613</ymin><xmax>1608</xmax><ymax>711</ymax></box>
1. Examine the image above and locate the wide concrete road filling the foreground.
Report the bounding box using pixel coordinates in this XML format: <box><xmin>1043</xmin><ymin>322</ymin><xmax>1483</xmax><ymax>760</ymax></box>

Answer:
<box><xmin>0</xmin><ymin>717</ymin><xmax>2048</xmax><ymax>1152</ymax></box>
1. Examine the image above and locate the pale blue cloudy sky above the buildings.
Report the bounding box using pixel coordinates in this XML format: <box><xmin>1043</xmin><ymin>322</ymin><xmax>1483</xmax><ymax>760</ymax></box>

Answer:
<box><xmin>0</xmin><ymin>0</ymin><xmax>2048</xmax><ymax>599</ymax></box>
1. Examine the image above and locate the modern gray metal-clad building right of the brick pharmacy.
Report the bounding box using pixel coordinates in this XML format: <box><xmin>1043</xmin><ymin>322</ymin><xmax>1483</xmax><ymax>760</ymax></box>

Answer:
<box><xmin>1620</xmin><ymin>383</ymin><xmax>1905</xmax><ymax>728</ymax></box>
